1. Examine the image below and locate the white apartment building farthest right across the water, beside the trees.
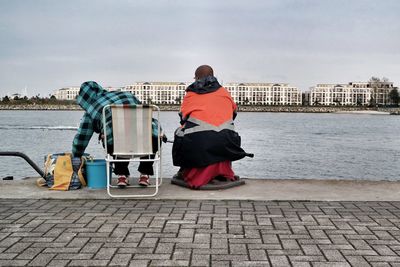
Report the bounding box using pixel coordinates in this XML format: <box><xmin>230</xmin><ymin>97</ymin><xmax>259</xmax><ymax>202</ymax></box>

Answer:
<box><xmin>310</xmin><ymin>82</ymin><xmax>372</xmax><ymax>106</ymax></box>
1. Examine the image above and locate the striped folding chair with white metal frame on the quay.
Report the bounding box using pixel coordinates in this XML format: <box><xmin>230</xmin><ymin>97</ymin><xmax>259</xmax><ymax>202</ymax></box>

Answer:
<box><xmin>103</xmin><ymin>104</ymin><xmax>162</xmax><ymax>197</ymax></box>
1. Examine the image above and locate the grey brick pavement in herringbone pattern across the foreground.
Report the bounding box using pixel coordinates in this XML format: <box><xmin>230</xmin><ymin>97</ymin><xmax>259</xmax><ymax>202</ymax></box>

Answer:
<box><xmin>0</xmin><ymin>199</ymin><xmax>400</xmax><ymax>266</ymax></box>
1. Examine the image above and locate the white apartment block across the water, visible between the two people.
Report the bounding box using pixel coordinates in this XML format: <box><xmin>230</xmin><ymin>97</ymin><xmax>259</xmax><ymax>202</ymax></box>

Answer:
<box><xmin>122</xmin><ymin>82</ymin><xmax>189</xmax><ymax>105</ymax></box>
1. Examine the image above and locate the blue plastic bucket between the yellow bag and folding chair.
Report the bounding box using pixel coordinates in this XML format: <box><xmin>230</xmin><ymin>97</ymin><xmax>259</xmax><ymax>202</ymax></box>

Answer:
<box><xmin>86</xmin><ymin>159</ymin><xmax>107</xmax><ymax>189</ymax></box>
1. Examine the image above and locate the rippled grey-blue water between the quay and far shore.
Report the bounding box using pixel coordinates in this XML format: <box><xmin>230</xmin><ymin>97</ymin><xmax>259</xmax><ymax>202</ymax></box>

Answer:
<box><xmin>0</xmin><ymin>111</ymin><xmax>400</xmax><ymax>180</ymax></box>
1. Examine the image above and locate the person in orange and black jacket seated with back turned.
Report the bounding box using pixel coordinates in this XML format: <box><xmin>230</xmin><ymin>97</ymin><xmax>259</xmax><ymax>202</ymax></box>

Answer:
<box><xmin>172</xmin><ymin>65</ymin><xmax>252</xmax><ymax>188</ymax></box>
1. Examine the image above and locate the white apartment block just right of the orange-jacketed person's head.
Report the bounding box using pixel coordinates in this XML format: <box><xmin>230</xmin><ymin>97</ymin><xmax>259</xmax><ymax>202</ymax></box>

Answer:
<box><xmin>224</xmin><ymin>83</ymin><xmax>301</xmax><ymax>105</ymax></box>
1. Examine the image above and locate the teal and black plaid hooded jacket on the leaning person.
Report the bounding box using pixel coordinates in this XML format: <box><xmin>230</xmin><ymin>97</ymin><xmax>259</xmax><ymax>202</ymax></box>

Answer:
<box><xmin>72</xmin><ymin>81</ymin><xmax>158</xmax><ymax>157</ymax></box>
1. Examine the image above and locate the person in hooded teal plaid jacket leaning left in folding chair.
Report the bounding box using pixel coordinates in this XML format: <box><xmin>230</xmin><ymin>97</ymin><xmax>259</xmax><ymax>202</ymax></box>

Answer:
<box><xmin>72</xmin><ymin>81</ymin><xmax>158</xmax><ymax>188</ymax></box>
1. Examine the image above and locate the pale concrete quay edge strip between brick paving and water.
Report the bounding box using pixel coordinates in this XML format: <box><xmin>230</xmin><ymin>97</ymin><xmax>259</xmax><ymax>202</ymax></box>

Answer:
<box><xmin>0</xmin><ymin>177</ymin><xmax>400</xmax><ymax>201</ymax></box>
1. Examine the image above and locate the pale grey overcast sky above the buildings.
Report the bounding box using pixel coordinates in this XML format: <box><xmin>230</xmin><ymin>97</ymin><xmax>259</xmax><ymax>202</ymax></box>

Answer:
<box><xmin>0</xmin><ymin>0</ymin><xmax>400</xmax><ymax>96</ymax></box>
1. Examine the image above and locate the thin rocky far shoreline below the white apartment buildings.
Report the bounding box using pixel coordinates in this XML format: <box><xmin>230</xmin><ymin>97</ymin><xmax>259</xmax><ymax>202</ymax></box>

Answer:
<box><xmin>0</xmin><ymin>104</ymin><xmax>400</xmax><ymax>115</ymax></box>
